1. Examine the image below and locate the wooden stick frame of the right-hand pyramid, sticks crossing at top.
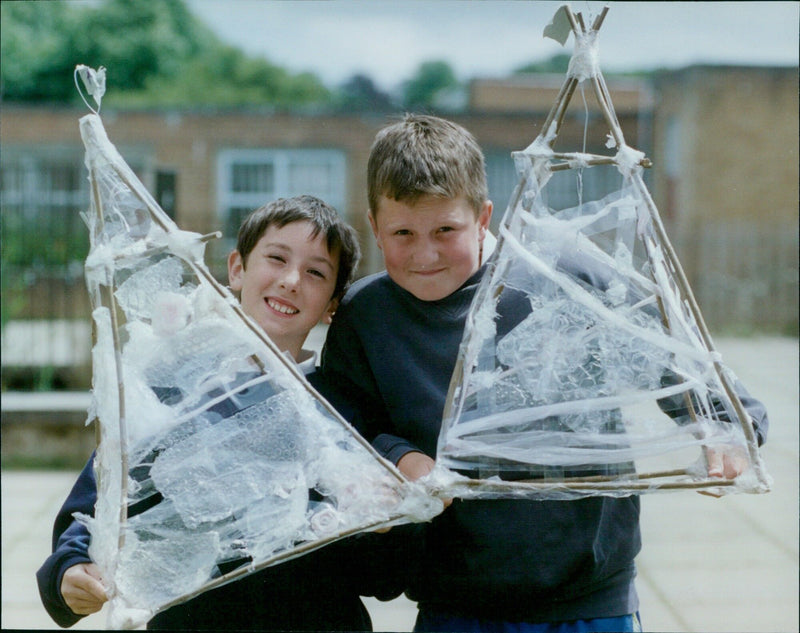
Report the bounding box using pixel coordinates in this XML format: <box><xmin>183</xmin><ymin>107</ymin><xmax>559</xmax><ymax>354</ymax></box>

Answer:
<box><xmin>441</xmin><ymin>5</ymin><xmax>769</xmax><ymax>496</ymax></box>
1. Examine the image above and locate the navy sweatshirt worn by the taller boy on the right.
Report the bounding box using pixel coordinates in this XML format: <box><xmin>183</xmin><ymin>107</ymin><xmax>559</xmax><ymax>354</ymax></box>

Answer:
<box><xmin>322</xmin><ymin>267</ymin><xmax>766</xmax><ymax>622</ymax></box>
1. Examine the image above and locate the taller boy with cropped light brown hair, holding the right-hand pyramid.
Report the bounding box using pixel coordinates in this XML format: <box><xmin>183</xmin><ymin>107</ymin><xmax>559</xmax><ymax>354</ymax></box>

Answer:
<box><xmin>322</xmin><ymin>115</ymin><xmax>766</xmax><ymax>632</ymax></box>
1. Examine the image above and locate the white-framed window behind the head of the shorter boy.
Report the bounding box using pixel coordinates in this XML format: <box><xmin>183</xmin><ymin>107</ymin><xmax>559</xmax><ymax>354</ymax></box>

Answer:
<box><xmin>217</xmin><ymin>149</ymin><xmax>346</xmax><ymax>250</ymax></box>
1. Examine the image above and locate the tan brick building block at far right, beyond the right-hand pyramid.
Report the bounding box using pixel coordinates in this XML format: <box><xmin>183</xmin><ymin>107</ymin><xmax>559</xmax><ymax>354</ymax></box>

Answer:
<box><xmin>653</xmin><ymin>66</ymin><xmax>799</xmax><ymax>335</ymax></box>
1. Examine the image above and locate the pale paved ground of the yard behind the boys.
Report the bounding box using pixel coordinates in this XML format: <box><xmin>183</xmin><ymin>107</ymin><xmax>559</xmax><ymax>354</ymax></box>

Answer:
<box><xmin>2</xmin><ymin>338</ymin><xmax>800</xmax><ymax>633</ymax></box>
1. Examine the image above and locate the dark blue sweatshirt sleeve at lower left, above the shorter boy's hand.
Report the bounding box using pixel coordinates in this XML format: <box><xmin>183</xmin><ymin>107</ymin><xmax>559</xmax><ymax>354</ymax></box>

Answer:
<box><xmin>36</xmin><ymin>455</ymin><xmax>97</xmax><ymax>627</ymax></box>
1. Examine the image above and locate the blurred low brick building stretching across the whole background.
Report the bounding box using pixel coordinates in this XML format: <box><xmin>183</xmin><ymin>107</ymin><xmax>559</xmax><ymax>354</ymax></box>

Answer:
<box><xmin>0</xmin><ymin>67</ymin><xmax>798</xmax><ymax>390</ymax></box>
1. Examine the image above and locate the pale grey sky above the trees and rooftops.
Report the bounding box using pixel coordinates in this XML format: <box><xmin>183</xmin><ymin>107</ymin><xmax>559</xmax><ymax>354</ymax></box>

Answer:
<box><xmin>188</xmin><ymin>0</ymin><xmax>800</xmax><ymax>89</ymax></box>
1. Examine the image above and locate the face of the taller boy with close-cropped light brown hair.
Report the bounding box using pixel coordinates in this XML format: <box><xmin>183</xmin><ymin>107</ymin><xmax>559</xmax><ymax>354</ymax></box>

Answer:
<box><xmin>369</xmin><ymin>195</ymin><xmax>492</xmax><ymax>301</ymax></box>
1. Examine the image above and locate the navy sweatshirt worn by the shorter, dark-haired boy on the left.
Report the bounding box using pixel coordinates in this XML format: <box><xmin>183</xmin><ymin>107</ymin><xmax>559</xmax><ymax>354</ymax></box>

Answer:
<box><xmin>36</xmin><ymin>374</ymin><xmax>417</xmax><ymax>631</ymax></box>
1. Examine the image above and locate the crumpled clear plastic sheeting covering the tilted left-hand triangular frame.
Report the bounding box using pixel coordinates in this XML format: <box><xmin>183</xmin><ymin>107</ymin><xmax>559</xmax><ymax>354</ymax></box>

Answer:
<box><xmin>81</xmin><ymin>115</ymin><xmax>442</xmax><ymax>629</ymax></box>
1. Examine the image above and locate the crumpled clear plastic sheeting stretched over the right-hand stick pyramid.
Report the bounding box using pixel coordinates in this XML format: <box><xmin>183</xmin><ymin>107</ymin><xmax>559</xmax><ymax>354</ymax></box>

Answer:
<box><xmin>428</xmin><ymin>156</ymin><xmax>763</xmax><ymax>499</ymax></box>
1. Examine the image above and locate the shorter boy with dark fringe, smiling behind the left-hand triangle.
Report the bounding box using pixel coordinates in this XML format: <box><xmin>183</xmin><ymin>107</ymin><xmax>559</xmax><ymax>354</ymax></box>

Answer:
<box><xmin>37</xmin><ymin>196</ymin><xmax>399</xmax><ymax>631</ymax></box>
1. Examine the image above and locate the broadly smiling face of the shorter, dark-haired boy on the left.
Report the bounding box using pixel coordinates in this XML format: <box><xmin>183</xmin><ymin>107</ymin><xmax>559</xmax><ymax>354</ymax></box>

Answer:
<box><xmin>228</xmin><ymin>221</ymin><xmax>339</xmax><ymax>359</ymax></box>
